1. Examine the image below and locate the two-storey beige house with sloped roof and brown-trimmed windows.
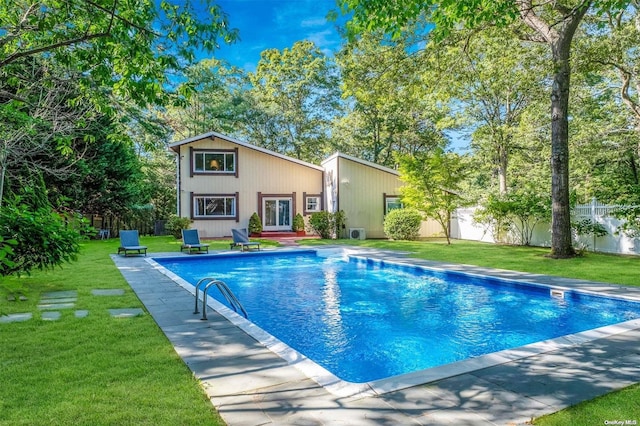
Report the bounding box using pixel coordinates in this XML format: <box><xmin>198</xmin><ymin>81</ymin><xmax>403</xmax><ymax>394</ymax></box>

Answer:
<box><xmin>169</xmin><ymin>132</ymin><xmax>439</xmax><ymax>238</ymax></box>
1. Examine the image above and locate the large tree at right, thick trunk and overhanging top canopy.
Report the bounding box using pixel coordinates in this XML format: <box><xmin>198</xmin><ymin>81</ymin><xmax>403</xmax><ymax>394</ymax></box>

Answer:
<box><xmin>339</xmin><ymin>0</ymin><xmax>628</xmax><ymax>257</ymax></box>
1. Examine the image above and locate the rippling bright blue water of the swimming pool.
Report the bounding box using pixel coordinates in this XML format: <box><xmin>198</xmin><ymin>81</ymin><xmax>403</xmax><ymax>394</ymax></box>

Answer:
<box><xmin>154</xmin><ymin>251</ymin><xmax>640</xmax><ymax>383</ymax></box>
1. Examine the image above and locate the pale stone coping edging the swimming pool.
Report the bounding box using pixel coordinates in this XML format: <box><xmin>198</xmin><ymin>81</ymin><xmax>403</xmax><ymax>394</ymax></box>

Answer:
<box><xmin>145</xmin><ymin>247</ymin><xmax>640</xmax><ymax>397</ymax></box>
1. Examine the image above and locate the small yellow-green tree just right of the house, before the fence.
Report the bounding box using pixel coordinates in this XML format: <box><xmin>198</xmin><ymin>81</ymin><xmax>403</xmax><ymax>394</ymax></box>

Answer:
<box><xmin>398</xmin><ymin>148</ymin><xmax>466</xmax><ymax>244</ymax></box>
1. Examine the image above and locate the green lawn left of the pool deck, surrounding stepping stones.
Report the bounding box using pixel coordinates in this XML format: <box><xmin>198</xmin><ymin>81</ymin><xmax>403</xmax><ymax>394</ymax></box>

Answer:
<box><xmin>0</xmin><ymin>237</ymin><xmax>262</xmax><ymax>425</ymax></box>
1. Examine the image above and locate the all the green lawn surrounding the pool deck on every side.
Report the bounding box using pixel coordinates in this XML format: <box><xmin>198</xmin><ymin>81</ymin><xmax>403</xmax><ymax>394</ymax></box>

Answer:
<box><xmin>0</xmin><ymin>237</ymin><xmax>640</xmax><ymax>426</ymax></box>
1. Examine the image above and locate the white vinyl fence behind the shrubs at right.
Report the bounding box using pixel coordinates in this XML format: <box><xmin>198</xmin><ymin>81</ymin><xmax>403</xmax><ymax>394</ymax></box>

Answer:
<box><xmin>451</xmin><ymin>200</ymin><xmax>640</xmax><ymax>254</ymax></box>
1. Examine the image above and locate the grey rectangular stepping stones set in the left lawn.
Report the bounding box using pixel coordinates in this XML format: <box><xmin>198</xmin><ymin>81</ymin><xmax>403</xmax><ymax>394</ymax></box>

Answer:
<box><xmin>0</xmin><ymin>288</ymin><xmax>144</xmax><ymax>324</ymax></box>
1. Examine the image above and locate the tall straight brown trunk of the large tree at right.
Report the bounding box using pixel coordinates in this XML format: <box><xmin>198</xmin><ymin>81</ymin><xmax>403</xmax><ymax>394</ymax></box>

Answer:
<box><xmin>551</xmin><ymin>44</ymin><xmax>575</xmax><ymax>257</ymax></box>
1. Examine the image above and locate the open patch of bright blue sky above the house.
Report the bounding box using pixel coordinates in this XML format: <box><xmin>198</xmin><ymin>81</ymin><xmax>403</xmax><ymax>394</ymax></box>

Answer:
<box><xmin>213</xmin><ymin>0</ymin><xmax>341</xmax><ymax>71</ymax></box>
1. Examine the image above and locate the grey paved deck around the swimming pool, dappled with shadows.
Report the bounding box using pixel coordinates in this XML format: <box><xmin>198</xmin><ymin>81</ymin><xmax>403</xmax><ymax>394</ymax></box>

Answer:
<box><xmin>112</xmin><ymin>250</ymin><xmax>640</xmax><ymax>426</ymax></box>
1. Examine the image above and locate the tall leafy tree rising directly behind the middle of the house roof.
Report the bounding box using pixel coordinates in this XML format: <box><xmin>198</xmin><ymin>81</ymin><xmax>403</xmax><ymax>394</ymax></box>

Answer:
<box><xmin>249</xmin><ymin>41</ymin><xmax>340</xmax><ymax>161</ymax></box>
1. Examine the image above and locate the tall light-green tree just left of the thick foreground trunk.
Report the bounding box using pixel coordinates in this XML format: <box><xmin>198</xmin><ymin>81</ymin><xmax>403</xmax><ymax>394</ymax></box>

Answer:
<box><xmin>432</xmin><ymin>28</ymin><xmax>546</xmax><ymax>194</ymax></box>
